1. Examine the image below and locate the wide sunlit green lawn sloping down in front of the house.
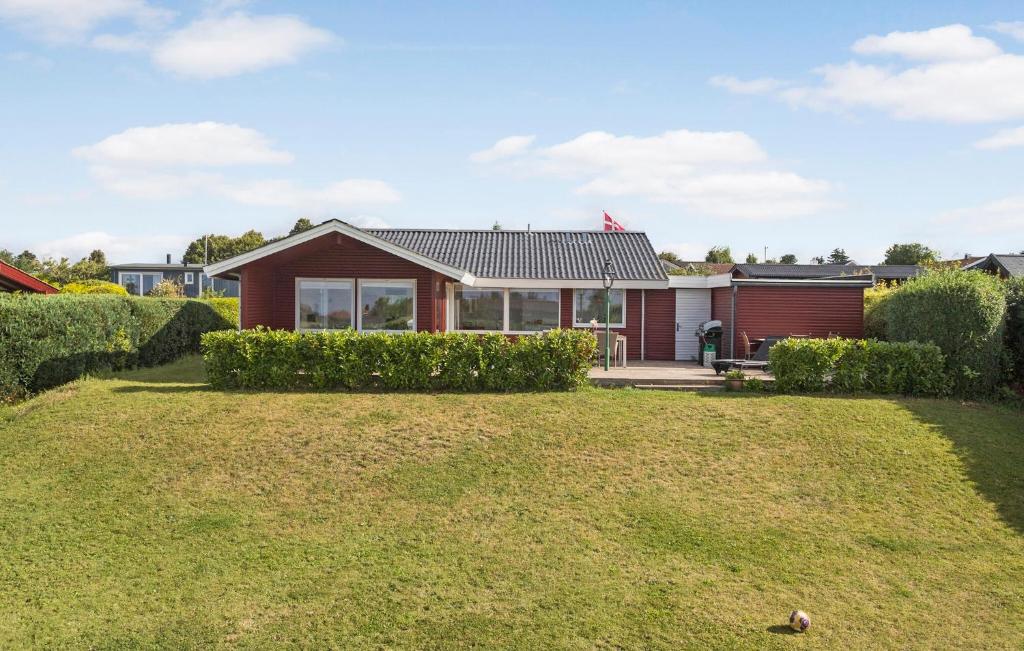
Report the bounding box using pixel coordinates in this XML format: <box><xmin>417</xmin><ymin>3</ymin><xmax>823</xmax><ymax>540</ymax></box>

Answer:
<box><xmin>0</xmin><ymin>359</ymin><xmax>1024</xmax><ymax>649</ymax></box>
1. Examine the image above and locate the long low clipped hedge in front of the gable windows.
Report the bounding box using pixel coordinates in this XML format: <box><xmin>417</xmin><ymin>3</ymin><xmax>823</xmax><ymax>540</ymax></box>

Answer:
<box><xmin>202</xmin><ymin>329</ymin><xmax>596</xmax><ymax>391</ymax></box>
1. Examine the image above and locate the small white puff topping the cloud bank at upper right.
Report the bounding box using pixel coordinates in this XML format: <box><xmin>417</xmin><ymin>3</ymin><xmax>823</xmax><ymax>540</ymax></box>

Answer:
<box><xmin>852</xmin><ymin>25</ymin><xmax>1001</xmax><ymax>61</ymax></box>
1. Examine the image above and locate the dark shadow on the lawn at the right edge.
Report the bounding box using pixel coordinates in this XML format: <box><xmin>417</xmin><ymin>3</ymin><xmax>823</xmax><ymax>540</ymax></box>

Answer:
<box><xmin>901</xmin><ymin>400</ymin><xmax>1024</xmax><ymax>535</ymax></box>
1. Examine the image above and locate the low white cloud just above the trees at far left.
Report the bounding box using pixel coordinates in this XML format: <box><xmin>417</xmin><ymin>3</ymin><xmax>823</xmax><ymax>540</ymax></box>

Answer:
<box><xmin>30</xmin><ymin>231</ymin><xmax>189</xmax><ymax>263</ymax></box>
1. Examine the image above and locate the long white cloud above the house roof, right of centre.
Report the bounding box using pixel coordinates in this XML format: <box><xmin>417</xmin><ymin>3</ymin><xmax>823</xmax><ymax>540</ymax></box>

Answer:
<box><xmin>475</xmin><ymin>130</ymin><xmax>831</xmax><ymax>219</ymax></box>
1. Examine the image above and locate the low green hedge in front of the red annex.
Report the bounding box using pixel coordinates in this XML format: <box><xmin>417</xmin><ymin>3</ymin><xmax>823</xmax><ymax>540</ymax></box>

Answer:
<box><xmin>768</xmin><ymin>339</ymin><xmax>949</xmax><ymax>395</ymax></box>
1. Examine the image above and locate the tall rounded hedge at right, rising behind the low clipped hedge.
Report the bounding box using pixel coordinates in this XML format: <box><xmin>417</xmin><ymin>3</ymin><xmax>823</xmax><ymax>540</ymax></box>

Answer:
<box><xmin>886</xmin><ymin>269</ymin><xmax>1007</xmax><ymax>396</ymax></box>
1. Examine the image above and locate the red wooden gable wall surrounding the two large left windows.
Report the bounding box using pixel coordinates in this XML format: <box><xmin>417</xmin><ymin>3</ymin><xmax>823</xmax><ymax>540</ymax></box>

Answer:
<box><xmin>241</xmin><ymin>233</ymin><xmax>444</xmax><ymax>331</ymax></box>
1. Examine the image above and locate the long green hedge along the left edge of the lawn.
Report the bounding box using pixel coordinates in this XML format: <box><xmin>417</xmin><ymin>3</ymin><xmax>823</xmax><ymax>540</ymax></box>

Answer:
<box><xmin>0</xmin><ymin>294</ymin><xmax>233</xmax><ymax>401</ymax></box>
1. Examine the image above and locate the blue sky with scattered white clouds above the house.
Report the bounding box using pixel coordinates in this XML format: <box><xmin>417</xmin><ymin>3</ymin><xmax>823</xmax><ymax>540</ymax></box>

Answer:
<box><xmin>0</xmin><ymin>0</ymin><xmax>1024</xmax><ymax>263</ymax></box>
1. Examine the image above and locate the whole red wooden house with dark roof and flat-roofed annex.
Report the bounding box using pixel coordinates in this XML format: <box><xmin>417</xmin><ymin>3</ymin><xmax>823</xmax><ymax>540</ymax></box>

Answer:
<box><xmin>205</xmin><ymin>220</ymin><xmax>871</xmax><ymax>359</ymax></box>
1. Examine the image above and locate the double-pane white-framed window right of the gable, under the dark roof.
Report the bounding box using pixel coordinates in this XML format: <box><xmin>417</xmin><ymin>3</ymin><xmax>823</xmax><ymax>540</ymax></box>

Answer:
<box><xmin>452</xmin><ymin>285</ymin><xmax>560</xmax><ymax>333</ymax></box>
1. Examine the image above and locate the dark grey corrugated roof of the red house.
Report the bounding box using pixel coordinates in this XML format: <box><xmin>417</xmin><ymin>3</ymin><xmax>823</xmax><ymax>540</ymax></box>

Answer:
<box><xmin>364</xmin><ymin>228</ymin><xmax>667</xmax><ymax>280</ymax></box>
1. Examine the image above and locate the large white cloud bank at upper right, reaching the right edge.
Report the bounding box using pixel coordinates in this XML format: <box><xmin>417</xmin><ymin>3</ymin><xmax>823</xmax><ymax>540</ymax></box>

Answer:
<box><xmin>720</xmin><ymin>25</ymin><xmax>1024</xmax><ymax>123</ymax></box>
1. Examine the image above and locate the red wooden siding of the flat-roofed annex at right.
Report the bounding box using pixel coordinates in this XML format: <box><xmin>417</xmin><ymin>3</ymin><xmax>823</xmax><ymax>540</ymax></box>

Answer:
<box><xmin>729</xmin><ymin>286</ymin><xmax>864</xmax><ymax>352</ymax></box>
